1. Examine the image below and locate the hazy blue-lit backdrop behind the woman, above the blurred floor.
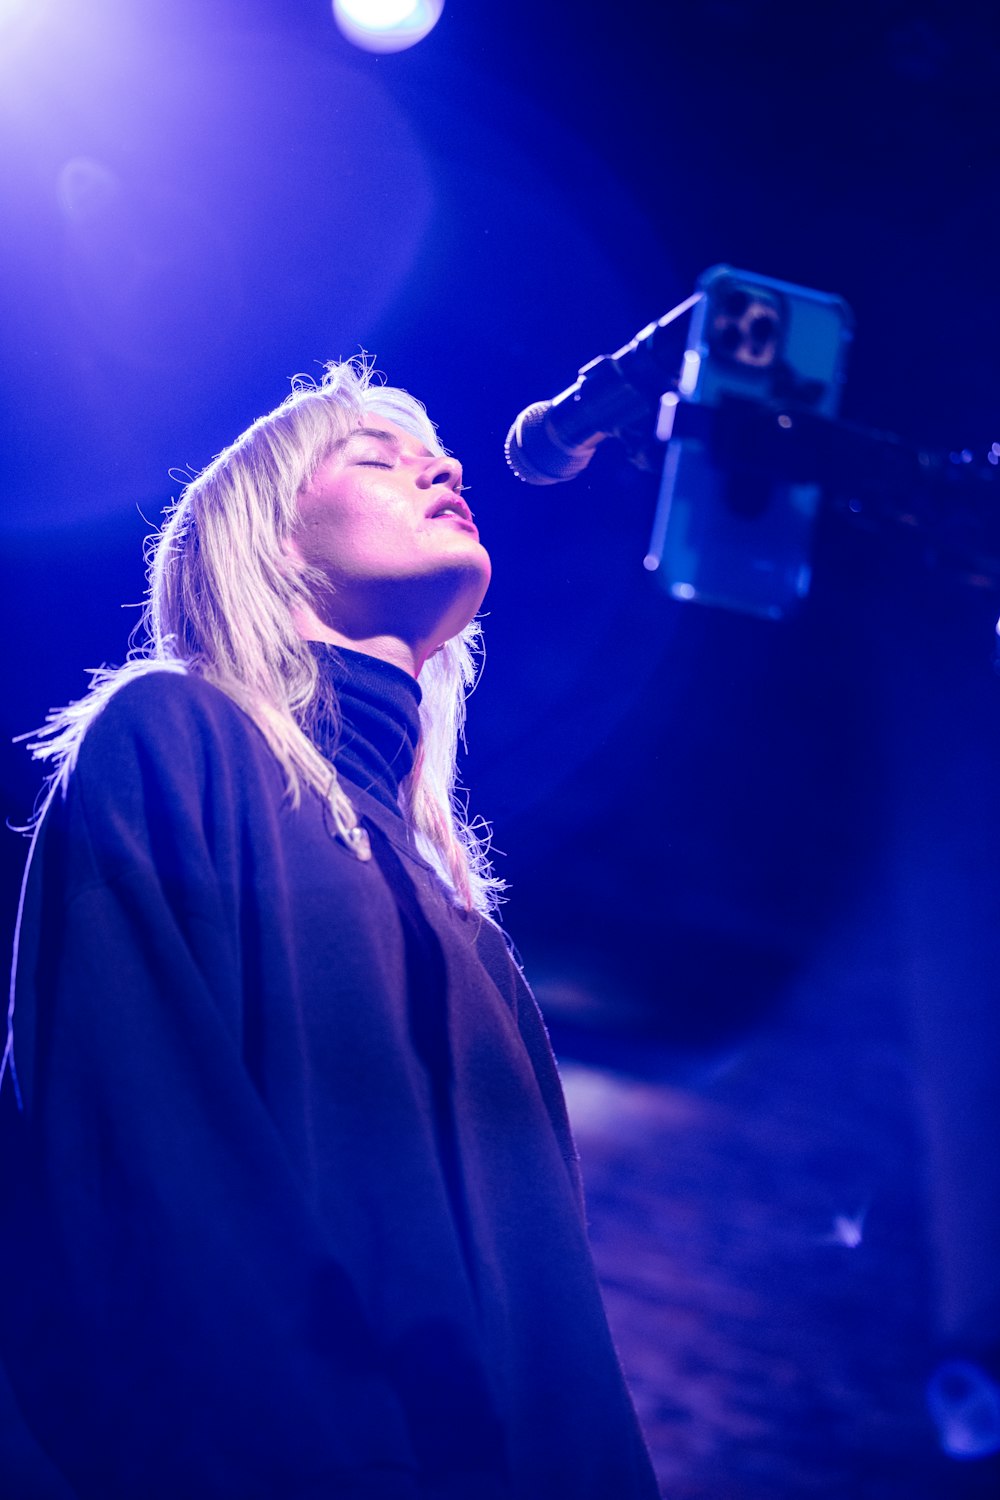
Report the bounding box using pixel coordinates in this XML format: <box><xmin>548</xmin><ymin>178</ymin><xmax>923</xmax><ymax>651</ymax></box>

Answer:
<box><xmin>0</xmin><ymin>0</ymin><xmax>1000</xmax><ymax>1496</ymax></box>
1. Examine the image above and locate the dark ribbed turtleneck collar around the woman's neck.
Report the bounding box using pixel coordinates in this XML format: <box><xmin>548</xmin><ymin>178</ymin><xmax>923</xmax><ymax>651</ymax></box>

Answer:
<box><xmin>309</xmin><ymin>641</ymin><xmax>420</xmax><ymax>813</ymax></box>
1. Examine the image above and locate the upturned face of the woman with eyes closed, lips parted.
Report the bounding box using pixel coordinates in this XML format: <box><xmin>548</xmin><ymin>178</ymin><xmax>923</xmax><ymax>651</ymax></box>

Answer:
<box><xmin>292</xmin><ymin>414</ymin><xmax>490</xmax><ymax>653</ymax></box>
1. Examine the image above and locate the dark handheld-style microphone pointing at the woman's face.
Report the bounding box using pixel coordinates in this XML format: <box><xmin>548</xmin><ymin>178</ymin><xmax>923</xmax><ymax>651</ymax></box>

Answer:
<box><xmin>504</xmin><ymin>293</ymin><xmax>703</xmax><ymax>485</ymax></box>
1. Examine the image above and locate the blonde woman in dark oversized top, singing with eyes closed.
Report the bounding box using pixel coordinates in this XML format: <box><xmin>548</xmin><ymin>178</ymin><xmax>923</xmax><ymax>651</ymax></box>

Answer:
<box><xmin>0</xmin><ymin>365</ymin><xmax>655</xmax><ymax>1500</ymax></box>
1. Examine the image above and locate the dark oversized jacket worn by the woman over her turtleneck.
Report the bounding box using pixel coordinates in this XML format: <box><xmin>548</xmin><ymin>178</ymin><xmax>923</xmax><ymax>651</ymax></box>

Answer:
<box><xmin>0</xmin><ymin>672</ymin><xmax>655</xmax><ymax>1500</ymax></box>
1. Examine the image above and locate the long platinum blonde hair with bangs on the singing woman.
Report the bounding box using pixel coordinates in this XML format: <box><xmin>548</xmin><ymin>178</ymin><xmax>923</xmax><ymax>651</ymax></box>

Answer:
<box><xmin>30</xmin><ymin>360</ymin><xmax>502</xmax><ymax>912</ymax></box>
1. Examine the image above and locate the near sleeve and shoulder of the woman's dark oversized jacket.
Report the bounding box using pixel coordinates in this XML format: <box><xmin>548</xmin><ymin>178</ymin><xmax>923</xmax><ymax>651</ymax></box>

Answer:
<box><xmin>0</xmin><ymin>674</ymin><xmax>423</xmax><ymax>1500</ymax></box>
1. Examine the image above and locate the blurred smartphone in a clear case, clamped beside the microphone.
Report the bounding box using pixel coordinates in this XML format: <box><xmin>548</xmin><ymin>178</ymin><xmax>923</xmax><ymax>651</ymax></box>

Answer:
<box><xmin>646</xmin><ymin>266</ymin><xmax>853</xmax><ymax>620</ymax></box>
